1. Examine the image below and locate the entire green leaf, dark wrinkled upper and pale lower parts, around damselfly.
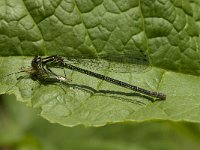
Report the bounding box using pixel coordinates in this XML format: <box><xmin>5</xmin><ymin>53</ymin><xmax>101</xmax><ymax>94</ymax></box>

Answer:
<box><xmin>0</xmin><ymin>0</ymin><xmax>200</xmax><ymax>126</ymax></box>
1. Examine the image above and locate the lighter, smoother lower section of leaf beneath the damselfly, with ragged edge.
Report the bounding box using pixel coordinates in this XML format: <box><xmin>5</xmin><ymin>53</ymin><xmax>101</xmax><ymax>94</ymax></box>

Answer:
<box><xmin>0</xmin><ymin>57</ymin><xmax>200</xmax><ymax>126</ymax></box>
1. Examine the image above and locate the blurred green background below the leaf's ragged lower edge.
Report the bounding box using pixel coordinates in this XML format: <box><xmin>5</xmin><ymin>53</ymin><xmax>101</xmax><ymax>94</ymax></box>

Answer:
<box><xmin>0</xmin><ymin>95</ymin><xmax>200</xmax><ymax>150</ymax></box>
